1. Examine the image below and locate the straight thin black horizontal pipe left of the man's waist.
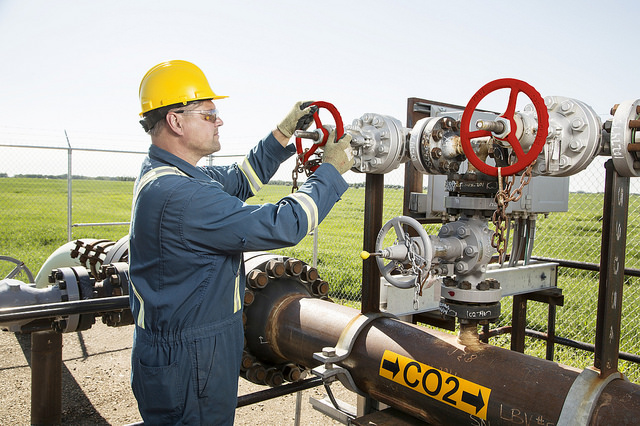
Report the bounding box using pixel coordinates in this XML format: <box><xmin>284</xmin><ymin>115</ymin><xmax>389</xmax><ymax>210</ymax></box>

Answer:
<box><xmin>0</xmin><ymin>296</ymin><xmax>129</xmax><ymax>324</ymax></box>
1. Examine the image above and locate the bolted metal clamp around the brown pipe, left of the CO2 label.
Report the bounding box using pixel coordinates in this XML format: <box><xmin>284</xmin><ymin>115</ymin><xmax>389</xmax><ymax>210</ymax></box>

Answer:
<box><xmin>311</xmin><ymin>312</ymin><xmax>396</xmax><ymax>396</ymax></box>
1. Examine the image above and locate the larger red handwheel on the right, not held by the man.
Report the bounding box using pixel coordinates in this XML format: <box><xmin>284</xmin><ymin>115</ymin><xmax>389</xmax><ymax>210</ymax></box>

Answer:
<box><xmin>460</xmin><ymin>78</ymin><xmax>549</xmax><ymax>176</ymax></box>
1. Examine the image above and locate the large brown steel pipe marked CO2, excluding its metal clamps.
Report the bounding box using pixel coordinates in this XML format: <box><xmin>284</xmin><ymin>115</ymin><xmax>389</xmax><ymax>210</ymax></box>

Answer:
<box><xmin>266</xmin><ymin>294</ymin><xmax>640</xmax><ymax>425</ymax></box>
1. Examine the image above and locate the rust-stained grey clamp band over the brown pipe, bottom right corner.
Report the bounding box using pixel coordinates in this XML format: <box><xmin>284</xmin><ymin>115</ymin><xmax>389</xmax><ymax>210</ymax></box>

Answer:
<box><xmin>556</xmin><ymin>368</ymin><xmax>627</xmax><ymax>426</ymax></box>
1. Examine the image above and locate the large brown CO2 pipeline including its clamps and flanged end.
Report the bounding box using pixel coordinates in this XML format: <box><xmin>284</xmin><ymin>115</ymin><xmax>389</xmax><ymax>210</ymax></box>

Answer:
<box><xmin>240</xmin><ymin>255</ymin><xmax>640</xmax><ymax>425</ymax></box>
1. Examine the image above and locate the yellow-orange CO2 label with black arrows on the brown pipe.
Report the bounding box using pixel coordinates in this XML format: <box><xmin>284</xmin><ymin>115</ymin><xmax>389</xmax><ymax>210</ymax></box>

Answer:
<box><xmin>380</xmin><ymin>350</ymin><xmax>491</xmax><ymax>420</ymax></box>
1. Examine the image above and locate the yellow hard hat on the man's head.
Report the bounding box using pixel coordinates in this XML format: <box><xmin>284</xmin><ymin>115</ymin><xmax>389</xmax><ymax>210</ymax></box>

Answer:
<box><xmin>139</xmin><ymin>61</ymin><xmax>228</xmax><ymax>115</ymax></box>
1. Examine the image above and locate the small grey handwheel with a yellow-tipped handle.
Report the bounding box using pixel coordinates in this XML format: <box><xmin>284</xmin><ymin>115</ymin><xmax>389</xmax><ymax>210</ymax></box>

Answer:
<box><xmin>372</xmin><ymin>216</ymin><xmax>433</xmax><ymax>288</ymax></box>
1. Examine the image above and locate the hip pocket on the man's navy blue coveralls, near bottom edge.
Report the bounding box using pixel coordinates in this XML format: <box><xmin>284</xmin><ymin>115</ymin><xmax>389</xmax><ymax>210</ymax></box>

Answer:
<box><xmin>131</xmin><ymin>359</ymin><xmax>184</xmax><ymax>422</ymax></box>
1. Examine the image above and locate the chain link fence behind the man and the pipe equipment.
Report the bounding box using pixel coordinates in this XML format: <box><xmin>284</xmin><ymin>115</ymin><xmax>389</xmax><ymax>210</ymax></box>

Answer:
<box><xmin>0</xmin><ymin>132</ymin><xmax>640</xmax><ymax>382</ymax></box>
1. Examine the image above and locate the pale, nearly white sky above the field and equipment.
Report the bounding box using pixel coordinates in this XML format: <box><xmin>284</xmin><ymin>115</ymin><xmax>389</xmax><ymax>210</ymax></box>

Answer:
<box><xmin>0</xmin><ymin>0</ymin><xmax>640</xmax><ymax>185</ymax></box>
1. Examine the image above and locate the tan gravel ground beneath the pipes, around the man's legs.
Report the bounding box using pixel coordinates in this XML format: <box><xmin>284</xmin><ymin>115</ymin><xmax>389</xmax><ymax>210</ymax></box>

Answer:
<box><xmin>0</xmin><ymin>323</ymin><xmax>356</xmax><ymax>426</ymax></box>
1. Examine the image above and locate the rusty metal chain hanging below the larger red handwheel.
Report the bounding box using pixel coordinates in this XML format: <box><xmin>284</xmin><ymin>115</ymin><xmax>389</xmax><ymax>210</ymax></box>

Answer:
<box><xmin>491</xmin><ymin>160</ymin><xmax>536</xmax><ymax>264</ymax></box>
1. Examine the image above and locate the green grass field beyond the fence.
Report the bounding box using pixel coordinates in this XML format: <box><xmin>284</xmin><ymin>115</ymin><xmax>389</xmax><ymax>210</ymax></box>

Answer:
<box><xmin>0</xmin><ymin>178</ymin><xmax>640</xmax><ymax>381</ymax></box>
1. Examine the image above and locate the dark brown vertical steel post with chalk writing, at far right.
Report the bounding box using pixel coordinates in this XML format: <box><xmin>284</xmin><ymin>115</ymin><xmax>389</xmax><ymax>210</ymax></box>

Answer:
<box><xmin>593</xmin><ymin>160</ymin><xmax>630</xmax><ymax>378</ymax></box>
